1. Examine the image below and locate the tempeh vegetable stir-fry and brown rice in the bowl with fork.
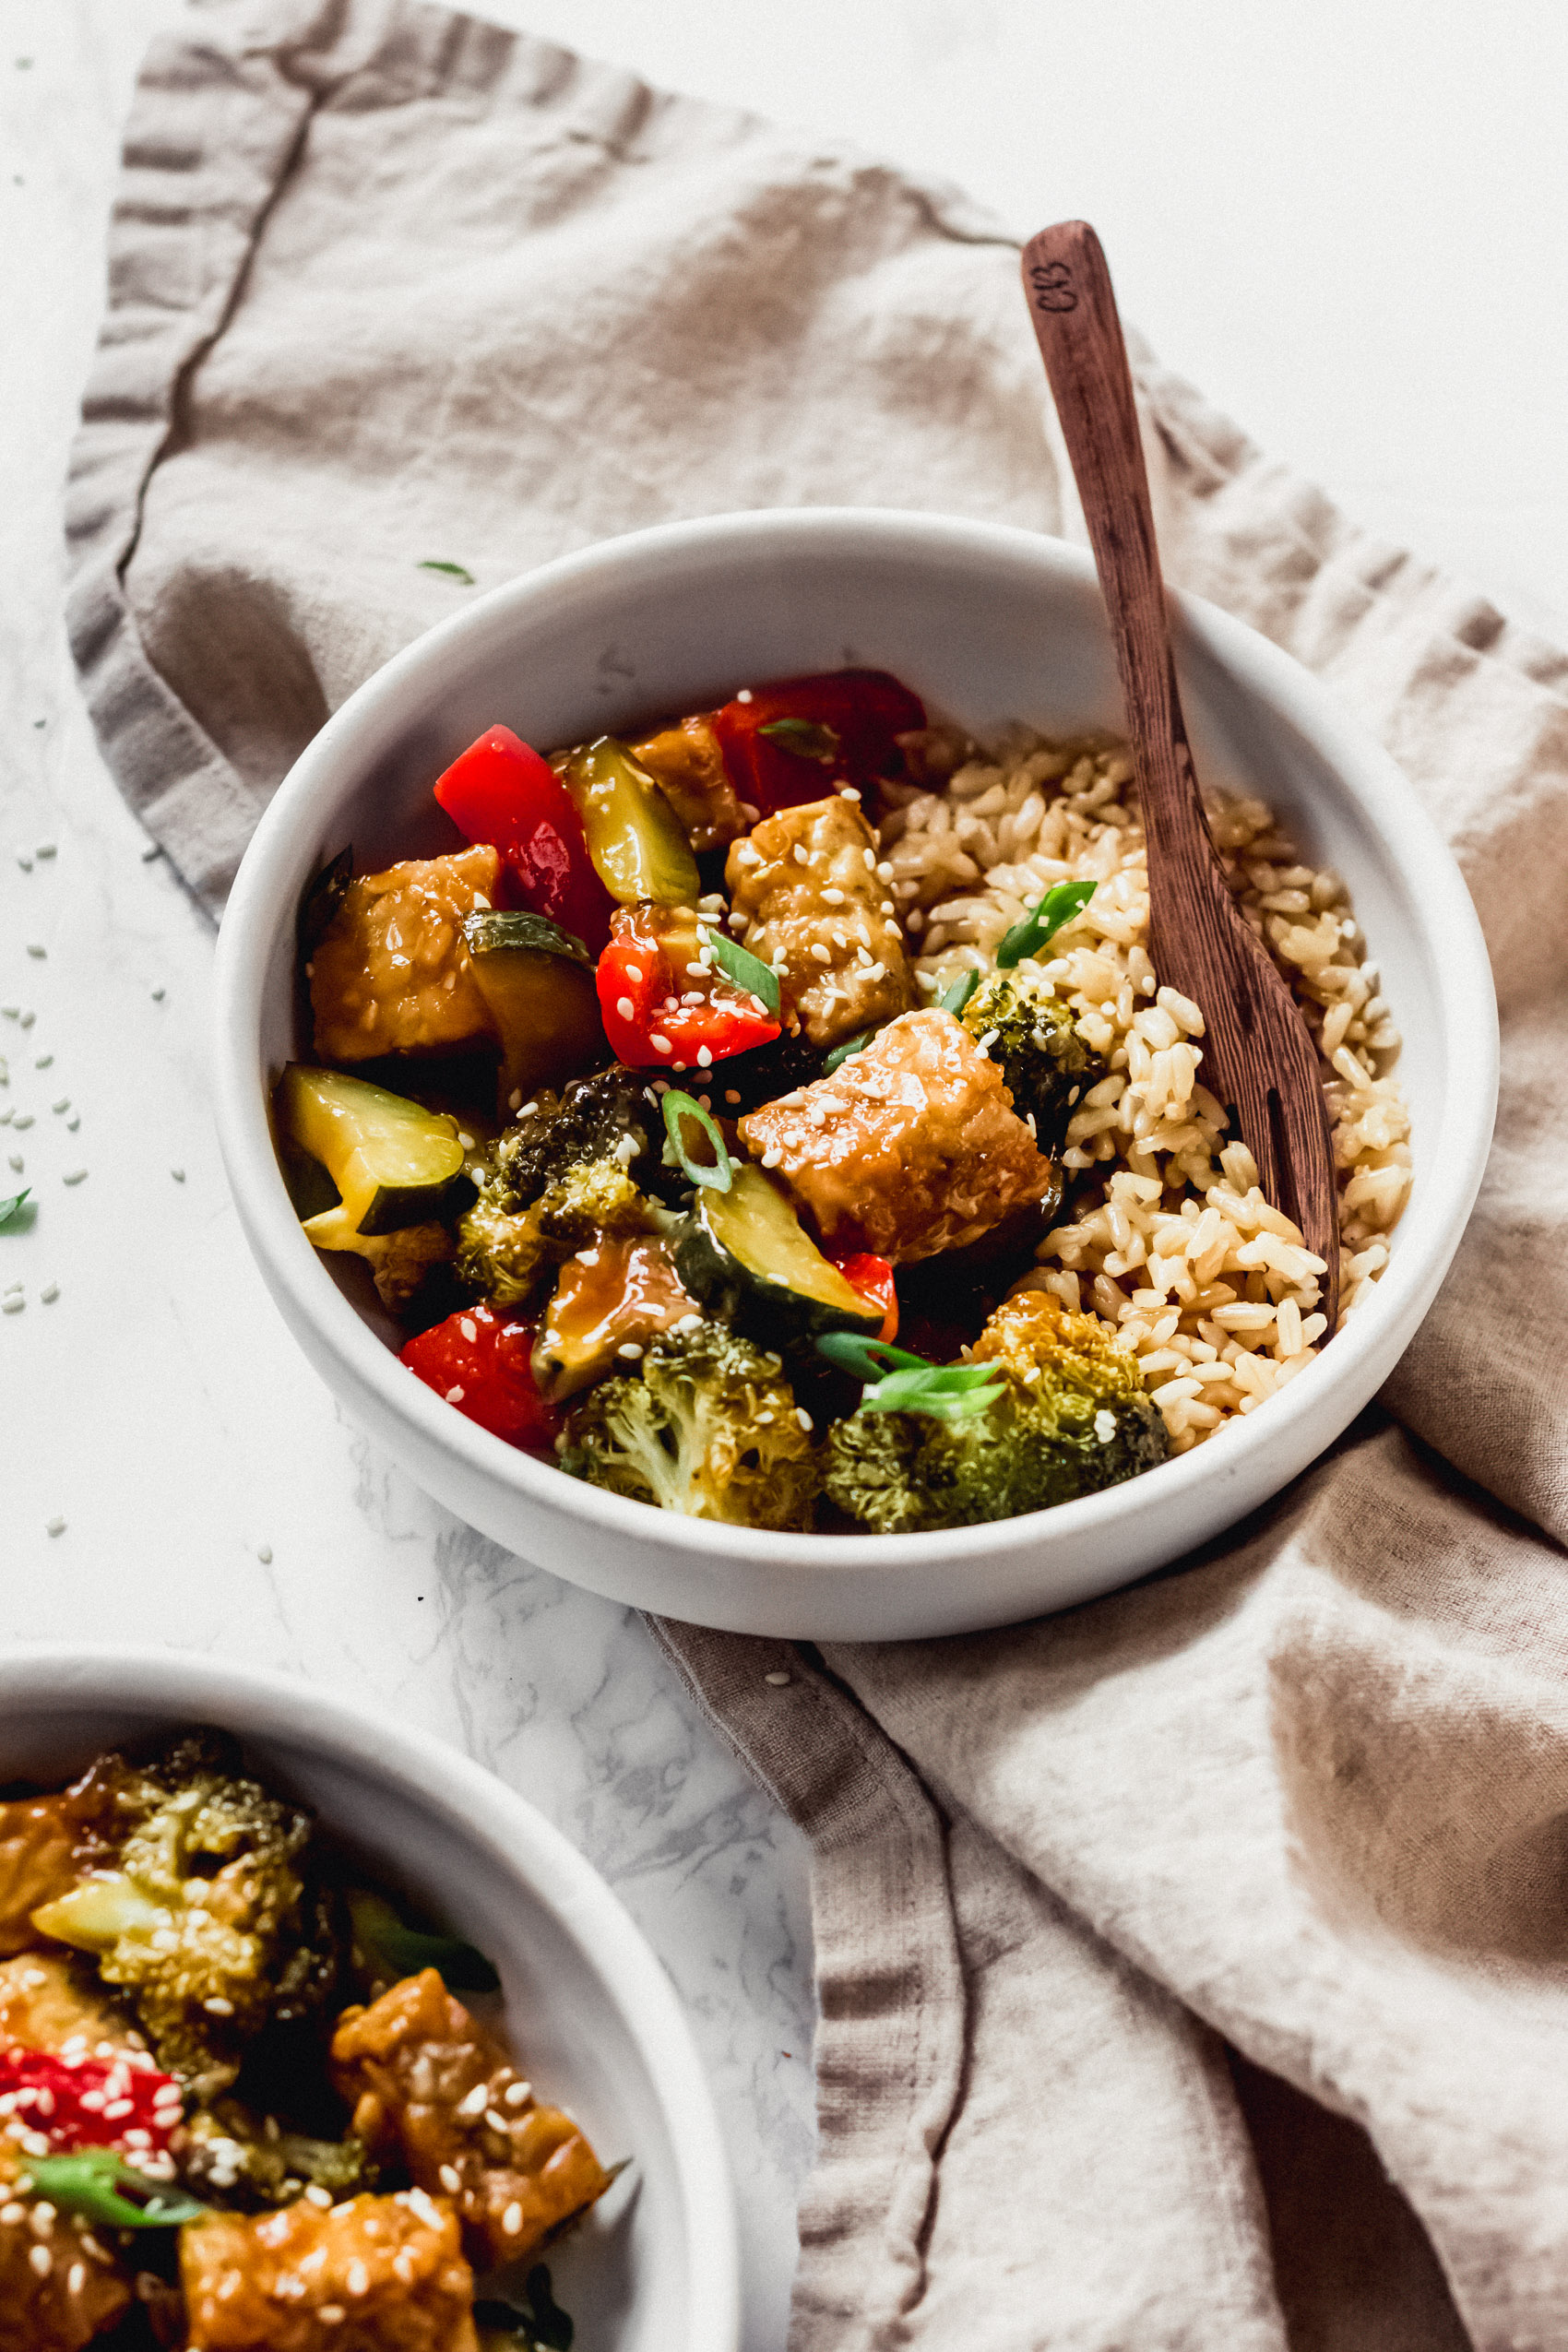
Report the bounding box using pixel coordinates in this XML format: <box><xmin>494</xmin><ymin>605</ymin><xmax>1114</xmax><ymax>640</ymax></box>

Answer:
<box><xmin>275</xmin><ymin>671</ymin><xmax>1410</xmax><ymax>1534</ymax></box>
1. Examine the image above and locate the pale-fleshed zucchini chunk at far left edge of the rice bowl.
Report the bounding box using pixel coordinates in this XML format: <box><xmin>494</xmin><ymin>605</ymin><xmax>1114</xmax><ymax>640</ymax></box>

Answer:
<box><xmin>278</xmin><ymin>1061</ymin><xmax>475</xmax><ymax>1256</ymax></box>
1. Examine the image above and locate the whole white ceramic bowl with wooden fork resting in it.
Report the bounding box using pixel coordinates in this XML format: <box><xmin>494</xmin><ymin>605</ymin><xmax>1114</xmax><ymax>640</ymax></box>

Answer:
<box><xmin>216</xmin><ymin>508</ymin><xmax>1498</xmax><ymax>1639</ymax></box>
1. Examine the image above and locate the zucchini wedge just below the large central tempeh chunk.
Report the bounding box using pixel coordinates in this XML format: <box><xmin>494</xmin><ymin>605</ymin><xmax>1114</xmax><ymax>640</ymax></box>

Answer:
<box><xmin>674</xmin><ymin>1164</ymin><xmax>882</xmax><ymax>1338</ymax></box>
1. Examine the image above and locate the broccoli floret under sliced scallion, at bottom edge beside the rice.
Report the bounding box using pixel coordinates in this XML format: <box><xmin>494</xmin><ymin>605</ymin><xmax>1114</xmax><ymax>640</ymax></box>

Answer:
<box><xmin>823</xmin><ymin>1291</ymin><xmax>1166</xmax><ymax>1536</ymax></box>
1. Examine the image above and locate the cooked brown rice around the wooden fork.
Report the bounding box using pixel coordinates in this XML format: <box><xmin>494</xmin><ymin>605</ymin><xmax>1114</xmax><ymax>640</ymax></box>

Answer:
<box><xmin>882</xmin><ymin>730</ymin><xmax>1410</xmax><ymax>1454</ymax></box>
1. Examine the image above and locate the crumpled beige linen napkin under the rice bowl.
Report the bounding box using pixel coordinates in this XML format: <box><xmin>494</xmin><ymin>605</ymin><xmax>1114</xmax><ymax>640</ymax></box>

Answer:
<box><xmin>70</xmin><ymin>0</ymin><xmax>1568</xmax><ymax>2352</ymax></box>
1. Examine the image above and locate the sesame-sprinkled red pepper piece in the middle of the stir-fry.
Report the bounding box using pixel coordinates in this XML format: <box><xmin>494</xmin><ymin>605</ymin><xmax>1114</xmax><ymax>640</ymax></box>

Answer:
<box><xmin>600</xmin><ymin>906</ymin><xmax>780</xmax><ymax>1070</ymax></box>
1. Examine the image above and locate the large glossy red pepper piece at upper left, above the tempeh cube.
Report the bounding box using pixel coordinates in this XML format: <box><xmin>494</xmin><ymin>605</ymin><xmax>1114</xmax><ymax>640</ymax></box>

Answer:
<box><xmin>435</xmin><ymin>727</ymin><xmax>616</xmax><ymax>955</ymax></box>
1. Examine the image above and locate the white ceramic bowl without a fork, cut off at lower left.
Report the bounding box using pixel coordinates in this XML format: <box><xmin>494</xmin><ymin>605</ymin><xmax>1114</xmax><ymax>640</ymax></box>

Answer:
<box><xmin>0</xmin><ymin>1649</ymin><xmax>738</xmax><ymax>2352</ymax></box>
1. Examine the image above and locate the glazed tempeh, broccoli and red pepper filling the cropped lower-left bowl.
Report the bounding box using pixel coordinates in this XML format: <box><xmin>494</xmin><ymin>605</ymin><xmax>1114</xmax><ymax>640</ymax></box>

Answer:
<box><xmin>0</xmin><ymin>1728</ymin><xmax>613</xmax><ymax>2352</ymax></box>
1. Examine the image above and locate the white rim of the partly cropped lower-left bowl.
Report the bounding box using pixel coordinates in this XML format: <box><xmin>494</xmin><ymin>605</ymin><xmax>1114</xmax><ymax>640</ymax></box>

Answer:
<box><xmin>0</xmin><ymin>1642</ymin><xmax>741</xmax><ymax>2352</ymax></box>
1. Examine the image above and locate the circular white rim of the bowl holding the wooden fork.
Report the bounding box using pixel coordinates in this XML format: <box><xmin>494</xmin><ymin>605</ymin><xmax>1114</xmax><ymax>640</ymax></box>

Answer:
<box><xmin>214</xmin><ymin>505</ymin><xmax>1498</xmax><ymax>1581</ymax></box>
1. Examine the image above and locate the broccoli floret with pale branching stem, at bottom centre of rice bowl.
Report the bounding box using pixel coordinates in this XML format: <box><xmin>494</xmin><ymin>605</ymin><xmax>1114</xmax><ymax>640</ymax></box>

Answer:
<box><xmin>562</xmin><ymin>1324</ymin><xmax>821</xmax><ymax>1529</ymax></box>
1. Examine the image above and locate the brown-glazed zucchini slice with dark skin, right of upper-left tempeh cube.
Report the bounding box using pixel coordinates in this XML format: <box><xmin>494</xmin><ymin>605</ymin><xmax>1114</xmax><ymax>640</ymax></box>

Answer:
<box><xmin>463</xmin><ymin>908</ymin><xmax>609</xmax><ymax>1120</ymax></box>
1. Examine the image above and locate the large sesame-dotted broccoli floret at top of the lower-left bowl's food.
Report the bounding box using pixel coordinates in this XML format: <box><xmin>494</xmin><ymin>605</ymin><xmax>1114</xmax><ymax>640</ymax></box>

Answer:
<box><xmin>33</xmin><ymin>1736</ymin><xmax>339</xmax><ymax>2100</ymax></box>
